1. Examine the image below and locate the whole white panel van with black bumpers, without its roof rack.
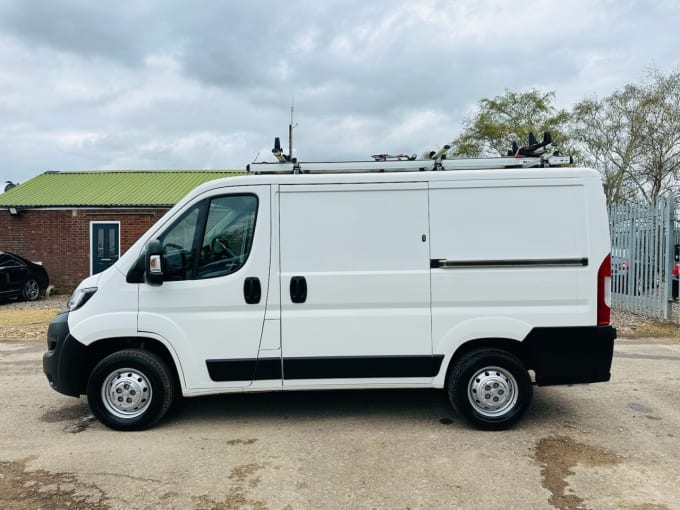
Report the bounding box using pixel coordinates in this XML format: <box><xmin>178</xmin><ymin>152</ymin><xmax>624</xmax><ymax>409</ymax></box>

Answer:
<box><xmin>43</xmin><ymin>162</ymin><xmax>616</xmax><ymax>430</ymax></box>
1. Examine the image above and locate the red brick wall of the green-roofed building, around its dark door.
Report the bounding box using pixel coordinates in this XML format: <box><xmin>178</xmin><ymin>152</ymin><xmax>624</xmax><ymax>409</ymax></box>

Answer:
<box><xmin>0</xmin><ymin>208</ymin><xmax>168</xmax><ymax>294</ymax></box>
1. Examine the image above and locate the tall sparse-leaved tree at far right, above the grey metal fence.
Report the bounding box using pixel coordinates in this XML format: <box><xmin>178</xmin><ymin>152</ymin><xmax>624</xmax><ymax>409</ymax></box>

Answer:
<box><xmin>571</xmin><ymin>70</ymin><xmax>680</xmax><ymax>204</ymax></box>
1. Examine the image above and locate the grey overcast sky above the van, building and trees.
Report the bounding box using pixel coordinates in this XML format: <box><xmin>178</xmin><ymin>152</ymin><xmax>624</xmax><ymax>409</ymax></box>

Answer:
<box><xmin>0</xmin><ymin>0</ymin><xmax>680</xmax><ymax>185</ymax></box>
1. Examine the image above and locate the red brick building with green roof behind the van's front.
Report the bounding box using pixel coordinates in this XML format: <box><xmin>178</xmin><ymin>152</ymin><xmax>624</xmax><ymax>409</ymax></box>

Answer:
<box><xmin>0</xmin><ymin>170</ymin><xmax>241</xmax><ymax>294</ymax></box>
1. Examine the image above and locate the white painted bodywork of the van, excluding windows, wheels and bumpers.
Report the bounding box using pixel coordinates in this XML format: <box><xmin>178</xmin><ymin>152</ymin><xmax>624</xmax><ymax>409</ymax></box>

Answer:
<box><xmin>46</xmin><ymin>168</ymin><xmax>609</xmax><ymax>402</ymax></box>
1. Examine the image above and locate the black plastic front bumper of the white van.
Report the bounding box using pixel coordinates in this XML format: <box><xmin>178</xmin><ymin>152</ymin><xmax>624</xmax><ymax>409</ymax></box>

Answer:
<box><xmin>43</xmin><ymin>312</ymin><xmax>86</xmax><ymax>397</ymax></box>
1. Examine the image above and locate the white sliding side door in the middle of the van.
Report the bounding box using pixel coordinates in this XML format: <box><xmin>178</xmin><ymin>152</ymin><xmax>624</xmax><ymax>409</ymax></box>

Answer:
<box><xmin>279</xmin><ymin>183</ymin><xmax>441</xmax><ymax>387</ymax></box>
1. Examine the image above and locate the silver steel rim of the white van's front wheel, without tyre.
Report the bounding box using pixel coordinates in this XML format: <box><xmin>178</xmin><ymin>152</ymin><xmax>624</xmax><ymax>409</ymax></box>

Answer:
<box><xmin>101</xmin><ymin>368</ymin><xmax>152</xmax><ymax>419</ymax></box>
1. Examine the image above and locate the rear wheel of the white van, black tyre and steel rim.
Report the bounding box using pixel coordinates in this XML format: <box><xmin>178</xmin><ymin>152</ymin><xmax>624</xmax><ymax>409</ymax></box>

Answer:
<box><xmin>448</xmin><ymin>349</ymin><xmax>533</xmax><ymax>430</ymax></box>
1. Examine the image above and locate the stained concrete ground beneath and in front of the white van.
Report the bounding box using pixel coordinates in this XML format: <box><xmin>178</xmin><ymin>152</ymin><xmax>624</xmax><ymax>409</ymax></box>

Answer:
<box><xmin>0</xmin><ymin>340</ymin><xmax>680</xmax><ymax>510</ymax></box>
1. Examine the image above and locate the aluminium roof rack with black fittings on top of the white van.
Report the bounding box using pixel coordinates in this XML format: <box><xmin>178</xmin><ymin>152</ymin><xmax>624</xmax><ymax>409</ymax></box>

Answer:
<box><xmin>246</xmin><ymin>131</ymin><xmax>572</xmax><ymax>174</ymax></box>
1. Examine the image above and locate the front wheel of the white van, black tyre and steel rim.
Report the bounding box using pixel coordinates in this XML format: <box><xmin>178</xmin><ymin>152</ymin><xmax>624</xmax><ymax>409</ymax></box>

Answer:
<box><xmin>87</xmin><ymin>349</ymin><xmax>175</xmax><ymax>430</ymax></box>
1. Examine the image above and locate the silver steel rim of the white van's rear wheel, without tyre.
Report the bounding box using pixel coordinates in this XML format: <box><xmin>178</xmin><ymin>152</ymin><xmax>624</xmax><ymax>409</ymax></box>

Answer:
<box><xmin>468</xmin><ymin>367</ymin><xmax>518</xmax><ymax>418</ymax></box>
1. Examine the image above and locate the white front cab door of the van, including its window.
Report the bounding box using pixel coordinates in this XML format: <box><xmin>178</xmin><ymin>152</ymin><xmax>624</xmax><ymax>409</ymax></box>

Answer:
<box><xmin>138</xmin><ymin>185</ymin><xmax>280</xmax><ymax>392</ymax></box>
